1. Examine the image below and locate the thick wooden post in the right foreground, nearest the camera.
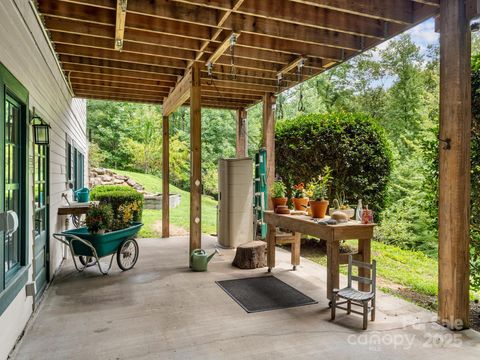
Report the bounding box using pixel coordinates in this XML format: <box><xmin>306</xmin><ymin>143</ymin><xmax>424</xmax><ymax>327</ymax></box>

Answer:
<box><xmin>438</xmin><ymin>0</ymin><xmax>471</xmax><ymax>330</ymax></box>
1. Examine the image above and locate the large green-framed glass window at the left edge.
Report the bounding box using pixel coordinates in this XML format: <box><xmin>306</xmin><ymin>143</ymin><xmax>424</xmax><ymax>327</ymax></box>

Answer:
<box><xmin>0</xmin><ymin>64</ymin><xmax>29</xmax><ymax>315</ymax></box>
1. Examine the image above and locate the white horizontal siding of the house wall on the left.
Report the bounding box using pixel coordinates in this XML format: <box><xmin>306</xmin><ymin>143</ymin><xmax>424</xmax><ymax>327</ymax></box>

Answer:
<box><xmin>0</xmin><ymin>0</ymin><xmax>88</xmax><ymax>359</ymax></box>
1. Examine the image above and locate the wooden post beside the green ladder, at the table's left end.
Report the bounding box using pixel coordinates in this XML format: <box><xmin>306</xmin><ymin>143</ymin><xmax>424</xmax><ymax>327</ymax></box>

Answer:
<box><xmin>263</xmin><ymin>93</ymin><xmax>276</xmax><ymax>210</ymax></box>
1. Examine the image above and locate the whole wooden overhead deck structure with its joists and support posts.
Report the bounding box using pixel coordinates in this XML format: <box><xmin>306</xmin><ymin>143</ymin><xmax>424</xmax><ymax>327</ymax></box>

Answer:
<box><xmin>37</xmin><ymin>0</ymin><xmax>478</xmax><ymax>329</ymax></box>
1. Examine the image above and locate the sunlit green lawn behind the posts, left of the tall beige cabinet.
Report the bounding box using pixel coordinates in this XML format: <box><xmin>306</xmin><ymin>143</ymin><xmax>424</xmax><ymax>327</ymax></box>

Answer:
<box><xmin>114</xmin><ymin>170</ymin><xmax>217</xmax><ymax>237</ymax></box>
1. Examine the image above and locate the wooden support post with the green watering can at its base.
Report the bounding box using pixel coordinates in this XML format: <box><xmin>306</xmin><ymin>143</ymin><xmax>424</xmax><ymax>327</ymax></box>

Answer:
<box><xmin>190</xmin><ymin>62</ymin><xmax>202</xmax><ymax>254</ymax></box>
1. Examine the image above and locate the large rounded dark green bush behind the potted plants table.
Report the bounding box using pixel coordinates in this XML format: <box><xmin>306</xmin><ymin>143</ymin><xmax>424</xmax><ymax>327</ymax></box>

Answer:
<box><xmin>275</xmin><ymin>113</ymin><xmax>392</xmax><ymax>212</ymax></box>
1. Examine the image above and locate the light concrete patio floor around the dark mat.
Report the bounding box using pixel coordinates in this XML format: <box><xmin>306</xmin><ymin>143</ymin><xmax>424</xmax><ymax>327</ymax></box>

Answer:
<box><xmin>12</xmin><ymin>237</ymin><xmax>480</xmax><ymax>360</ymax></box>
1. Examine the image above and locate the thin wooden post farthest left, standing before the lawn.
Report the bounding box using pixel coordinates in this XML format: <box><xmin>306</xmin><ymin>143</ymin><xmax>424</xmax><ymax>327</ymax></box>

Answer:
<box><xmin>162</xmin><ymin>116</ymin><xmax>170</xmax><ymax>238</ymax></box>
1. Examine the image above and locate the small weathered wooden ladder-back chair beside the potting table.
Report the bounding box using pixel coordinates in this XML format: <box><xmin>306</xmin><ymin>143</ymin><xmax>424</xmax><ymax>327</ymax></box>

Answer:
<box><xmin>331</xmin><ymin>255</ymin><xmax>377</xmax><ymax>330</ymax></box>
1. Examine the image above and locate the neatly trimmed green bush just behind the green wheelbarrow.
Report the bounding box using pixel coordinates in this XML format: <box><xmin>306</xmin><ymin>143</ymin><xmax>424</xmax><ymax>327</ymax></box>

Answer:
<box><xmin>90</xmin><ymin>185</ymin><xmax>143</xmax><ymax>230</ymax></box>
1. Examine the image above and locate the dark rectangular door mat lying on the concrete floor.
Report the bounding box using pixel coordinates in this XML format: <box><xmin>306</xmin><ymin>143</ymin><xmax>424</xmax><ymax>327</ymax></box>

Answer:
<box><xmin>216</xmin><ymin>276</ymin><xmax>317</xmax><ymax>313</ymax></box>
